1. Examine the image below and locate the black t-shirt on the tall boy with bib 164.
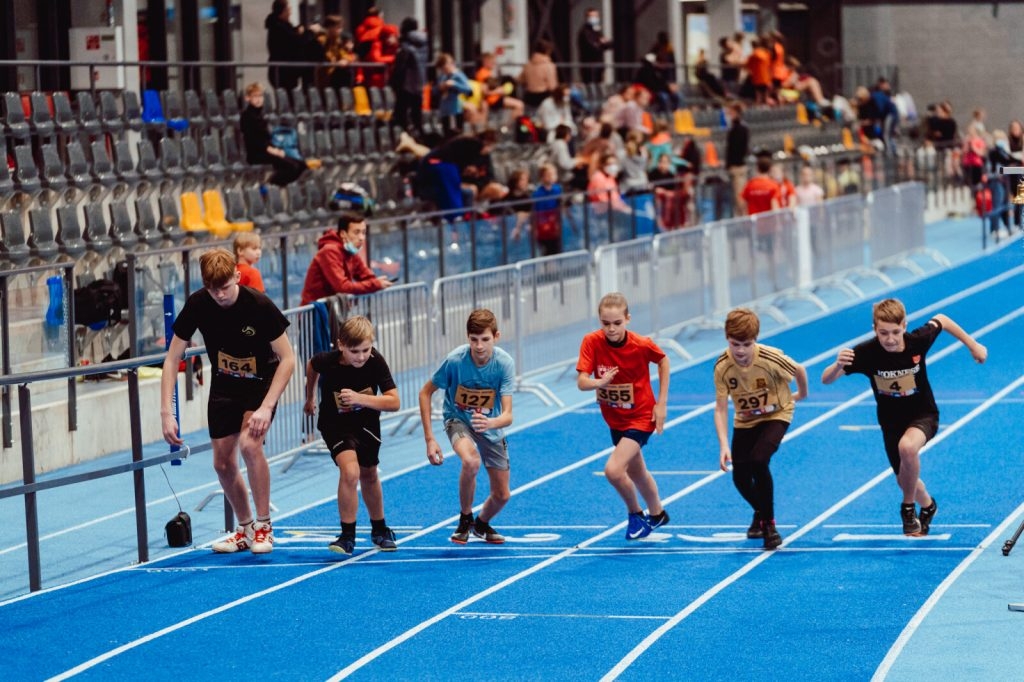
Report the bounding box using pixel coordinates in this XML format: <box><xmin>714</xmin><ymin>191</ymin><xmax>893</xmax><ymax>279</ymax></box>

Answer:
<box><xmin>173</xmin><ymin>287</ymin><xmax>290</xmax><ymax>395</ymax></box>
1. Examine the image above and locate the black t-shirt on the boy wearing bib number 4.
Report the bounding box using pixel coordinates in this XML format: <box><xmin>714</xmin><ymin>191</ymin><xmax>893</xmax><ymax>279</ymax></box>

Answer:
<box><xmin>845</xmin><ymin>319</ymin><xmax>942</xmax><ymax>424</ymax></box>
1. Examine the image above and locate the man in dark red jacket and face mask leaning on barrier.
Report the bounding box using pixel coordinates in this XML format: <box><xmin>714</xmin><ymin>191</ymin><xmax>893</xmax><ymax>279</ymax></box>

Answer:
<box><xmin>302</xmin><ymin>211</ymin><xmax>391</xmax><ymax>305</ymax></box>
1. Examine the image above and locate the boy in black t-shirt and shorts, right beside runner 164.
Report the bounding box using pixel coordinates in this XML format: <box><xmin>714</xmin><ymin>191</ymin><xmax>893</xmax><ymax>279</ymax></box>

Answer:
<box><xmin>304</xmin><ymin>315</ymin><xmax>399</xmax><ymax>554</ymax></box>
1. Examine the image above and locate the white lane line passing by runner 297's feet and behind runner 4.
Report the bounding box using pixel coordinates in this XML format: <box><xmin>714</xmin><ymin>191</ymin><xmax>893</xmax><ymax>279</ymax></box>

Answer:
<box><xmin>601</xmin><ymin>366</ymin><xmax>1024</xmax><ymax>681</ymax></box>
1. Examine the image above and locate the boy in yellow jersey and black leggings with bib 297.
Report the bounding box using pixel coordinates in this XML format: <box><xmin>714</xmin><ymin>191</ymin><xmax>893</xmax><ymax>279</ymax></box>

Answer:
<box><xmin>715</xmin><ymin>308</ymin><xmax>807</xmax><ymax>550</ymax></box>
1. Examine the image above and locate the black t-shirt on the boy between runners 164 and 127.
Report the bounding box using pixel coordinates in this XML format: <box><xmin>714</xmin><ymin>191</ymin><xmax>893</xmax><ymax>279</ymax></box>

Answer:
<box><xmin>309</xmin><ymin>348</ymin><xmax>396</xmax><ymax>434</ymax></box>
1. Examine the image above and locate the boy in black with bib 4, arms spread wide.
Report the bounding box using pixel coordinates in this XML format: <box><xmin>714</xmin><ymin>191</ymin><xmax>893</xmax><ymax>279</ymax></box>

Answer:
<box><xmin>821</xmin><ymin>298</ymin><xmax>988</xmax><ymax>536</ymax></box>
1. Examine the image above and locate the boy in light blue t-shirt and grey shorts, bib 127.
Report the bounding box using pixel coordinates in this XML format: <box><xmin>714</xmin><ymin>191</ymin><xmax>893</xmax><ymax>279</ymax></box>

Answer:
<box><xmin>420</xmin><ymin>308</ymin><xmax>515</xmax><ymax>545</ymax></box>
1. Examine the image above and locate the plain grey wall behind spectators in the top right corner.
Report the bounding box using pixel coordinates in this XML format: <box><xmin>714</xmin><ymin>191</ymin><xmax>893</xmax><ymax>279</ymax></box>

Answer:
<box><xmin>843</xmin><ymin>2</ymin><xmax>1024</xmax><ymax>130</ymax></box>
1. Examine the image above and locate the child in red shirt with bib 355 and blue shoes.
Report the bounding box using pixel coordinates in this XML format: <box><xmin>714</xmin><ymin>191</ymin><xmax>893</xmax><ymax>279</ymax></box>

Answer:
<box><xmin>577</xmin><ymin>293</ymin><xmax>669</xmax><ymax>540</ymax></box>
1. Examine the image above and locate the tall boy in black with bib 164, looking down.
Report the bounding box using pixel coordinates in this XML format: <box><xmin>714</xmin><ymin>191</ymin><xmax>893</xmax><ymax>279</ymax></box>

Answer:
<box><xmin>160</xmin><ymin>248</ymin><xmax>295</xmax><ymax>554</ymax></box>
